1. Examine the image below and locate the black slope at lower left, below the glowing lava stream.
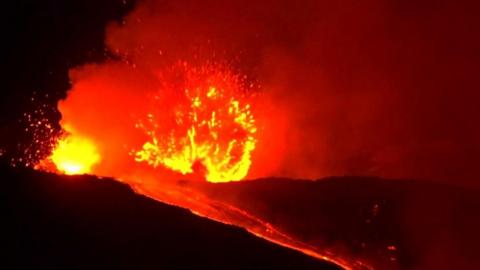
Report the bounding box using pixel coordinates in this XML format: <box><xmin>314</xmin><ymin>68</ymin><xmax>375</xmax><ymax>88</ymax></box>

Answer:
<box><xmin>0</xmin><ymin>167</ymin><xmax>338</xmax><ymax>269</ymax></box>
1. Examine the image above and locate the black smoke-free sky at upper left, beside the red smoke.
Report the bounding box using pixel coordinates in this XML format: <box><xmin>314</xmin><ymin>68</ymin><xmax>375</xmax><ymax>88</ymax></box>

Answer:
<box><xmin>0</xmin><ymin>0</ymin><xmax>132</xmax><ymax>162</ymax></box>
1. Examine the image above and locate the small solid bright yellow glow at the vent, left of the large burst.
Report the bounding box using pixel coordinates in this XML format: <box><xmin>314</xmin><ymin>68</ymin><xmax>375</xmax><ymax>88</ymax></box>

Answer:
<box><xmin>50</xmin><ymin>135</ymin><xmax>100</xmax><ymax>175</ymax></box>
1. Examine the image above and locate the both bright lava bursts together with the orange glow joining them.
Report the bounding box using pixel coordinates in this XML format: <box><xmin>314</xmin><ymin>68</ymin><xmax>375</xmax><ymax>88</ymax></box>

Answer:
<box><xmin>38</xmin><ymin>61</ymin><xmax>257</xmax><ymax>182</ymax></box>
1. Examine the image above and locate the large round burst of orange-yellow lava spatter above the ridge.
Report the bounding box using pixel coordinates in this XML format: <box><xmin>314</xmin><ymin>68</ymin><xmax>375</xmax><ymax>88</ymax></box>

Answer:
<box><xmin>135</xmin><ymin>63</ymin><xmax>257</xmax><ymax>182</ymax></box>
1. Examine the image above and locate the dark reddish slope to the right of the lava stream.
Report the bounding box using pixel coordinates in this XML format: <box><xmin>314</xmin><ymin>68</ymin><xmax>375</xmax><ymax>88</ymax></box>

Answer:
<box><xmin>192</xmin><ymin>177</ymin><xmax>480</xmax><ymax>269</ymax></box>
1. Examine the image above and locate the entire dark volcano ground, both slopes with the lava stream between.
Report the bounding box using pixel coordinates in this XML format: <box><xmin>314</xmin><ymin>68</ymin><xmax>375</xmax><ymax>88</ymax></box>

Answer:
<box><xmin>1</xmin><ymin>162</ymin><xmax>480</xmax><ymax>269</ymax></box>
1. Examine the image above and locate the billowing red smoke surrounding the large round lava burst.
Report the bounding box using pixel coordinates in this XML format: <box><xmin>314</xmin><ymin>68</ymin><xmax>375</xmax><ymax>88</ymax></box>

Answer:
<box><xmin>60</xmin><ymin>0</ymin><xmax>480</xmax><ymax>184</ymax></box>
